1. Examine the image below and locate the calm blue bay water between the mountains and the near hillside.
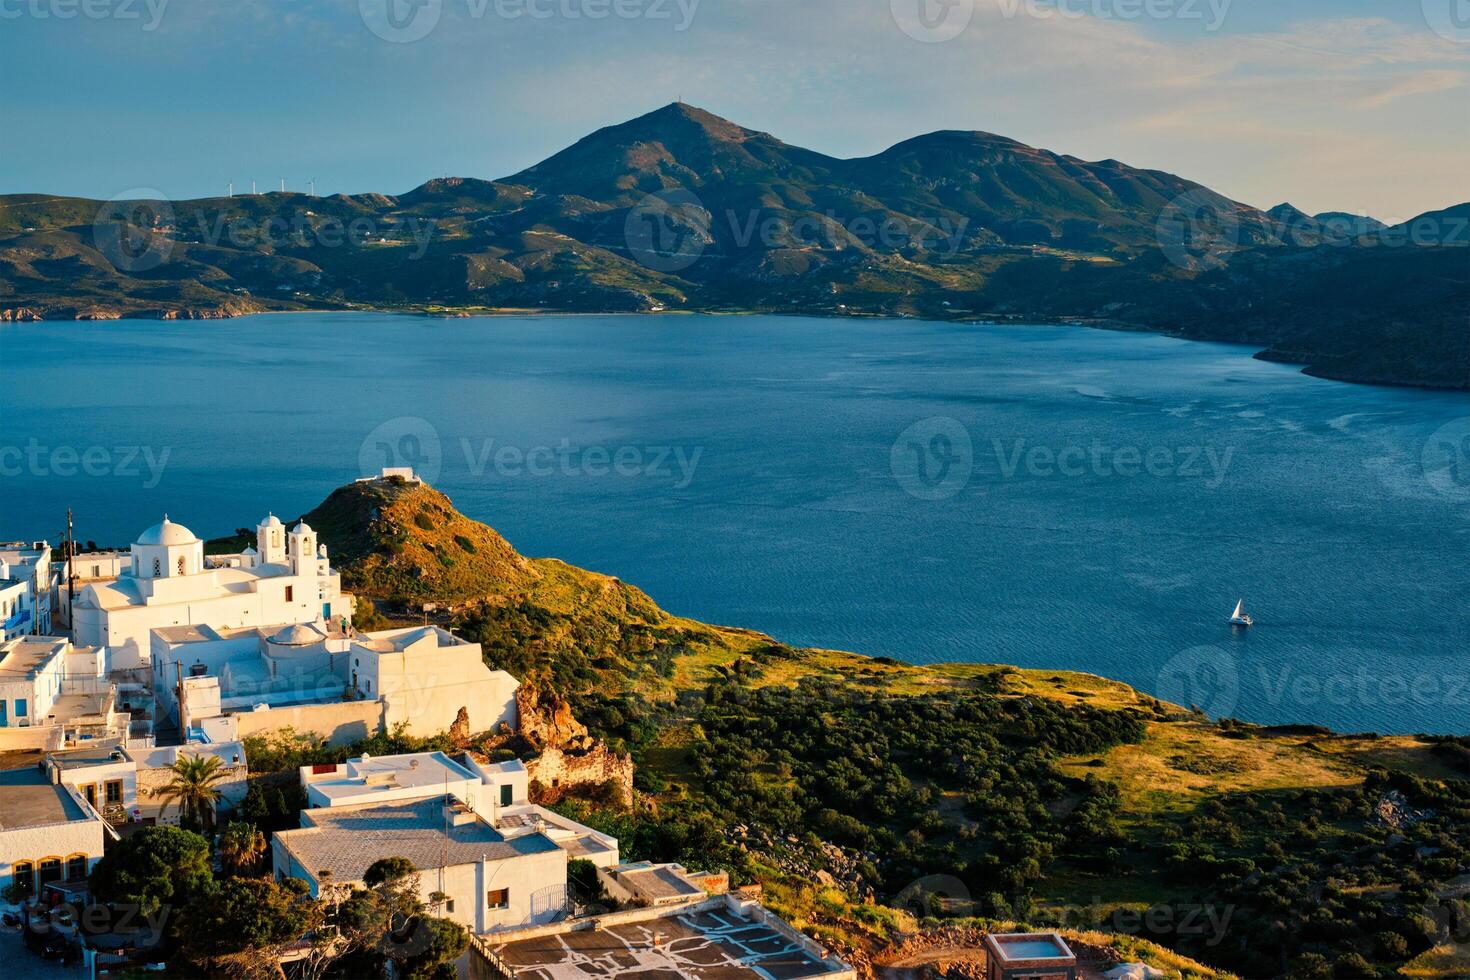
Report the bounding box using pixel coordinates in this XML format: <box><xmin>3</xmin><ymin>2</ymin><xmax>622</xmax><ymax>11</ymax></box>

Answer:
<box><xmin>0</xmin><ymin>314</ymin><xmax>1470</xmax><ymax>732</ymax></box>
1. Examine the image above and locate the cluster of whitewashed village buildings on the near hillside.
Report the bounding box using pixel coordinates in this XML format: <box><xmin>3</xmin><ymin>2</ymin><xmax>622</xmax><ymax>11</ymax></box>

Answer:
<box><xmin>0</xmin><ymin>472</ymin><xmax>1076</xmax><ymax>980</ymax></box>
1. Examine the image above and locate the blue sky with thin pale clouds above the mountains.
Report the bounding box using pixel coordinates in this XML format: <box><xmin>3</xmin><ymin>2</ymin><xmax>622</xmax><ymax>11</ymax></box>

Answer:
<box><xmin>0</xmin><ymin>0</ymin><xmax>1470</xmax><ymax>220</ymax></box>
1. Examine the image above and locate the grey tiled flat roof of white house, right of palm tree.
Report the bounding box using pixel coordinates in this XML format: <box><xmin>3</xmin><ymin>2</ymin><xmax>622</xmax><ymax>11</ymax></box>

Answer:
<box><xmin>275</xmin><ymin>796</ymin><xmax>557</xmax><ymax>883</ymax></box>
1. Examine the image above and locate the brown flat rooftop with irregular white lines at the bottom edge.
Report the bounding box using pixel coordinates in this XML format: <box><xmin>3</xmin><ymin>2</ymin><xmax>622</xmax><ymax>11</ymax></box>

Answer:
<box><xmin>495</xmin><ymin>908</ymin><xmax>832</xmax><ymax>980</ymax></box>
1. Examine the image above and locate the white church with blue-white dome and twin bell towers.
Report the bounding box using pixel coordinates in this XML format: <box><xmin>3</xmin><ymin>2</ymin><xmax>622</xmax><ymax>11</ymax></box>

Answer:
<box><xmin>74</xmin><ymin>514</ymin><xmax>353</xmax><ymax>671</ymax></box>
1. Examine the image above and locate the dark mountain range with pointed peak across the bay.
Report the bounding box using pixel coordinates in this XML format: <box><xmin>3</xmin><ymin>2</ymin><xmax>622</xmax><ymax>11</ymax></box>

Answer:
<box><xmin>0</xmin><ymin>103</ymin><xmax>1470</xmax><ymax>388</ymax></box>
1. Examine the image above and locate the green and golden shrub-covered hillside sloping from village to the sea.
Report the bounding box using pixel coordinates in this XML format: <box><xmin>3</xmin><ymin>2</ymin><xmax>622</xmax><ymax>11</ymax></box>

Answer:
<box><xmin>238</xmin><ymin>479</ymin><xmax>1470</xmax><ymax>977</ymax></box>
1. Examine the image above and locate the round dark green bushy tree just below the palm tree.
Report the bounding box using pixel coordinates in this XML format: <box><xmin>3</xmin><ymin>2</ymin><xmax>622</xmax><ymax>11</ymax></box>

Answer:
<box><xmin>91</xmin><ymin>827</ymin><xmax>213</xmax><ymax>915</ymax></box>
